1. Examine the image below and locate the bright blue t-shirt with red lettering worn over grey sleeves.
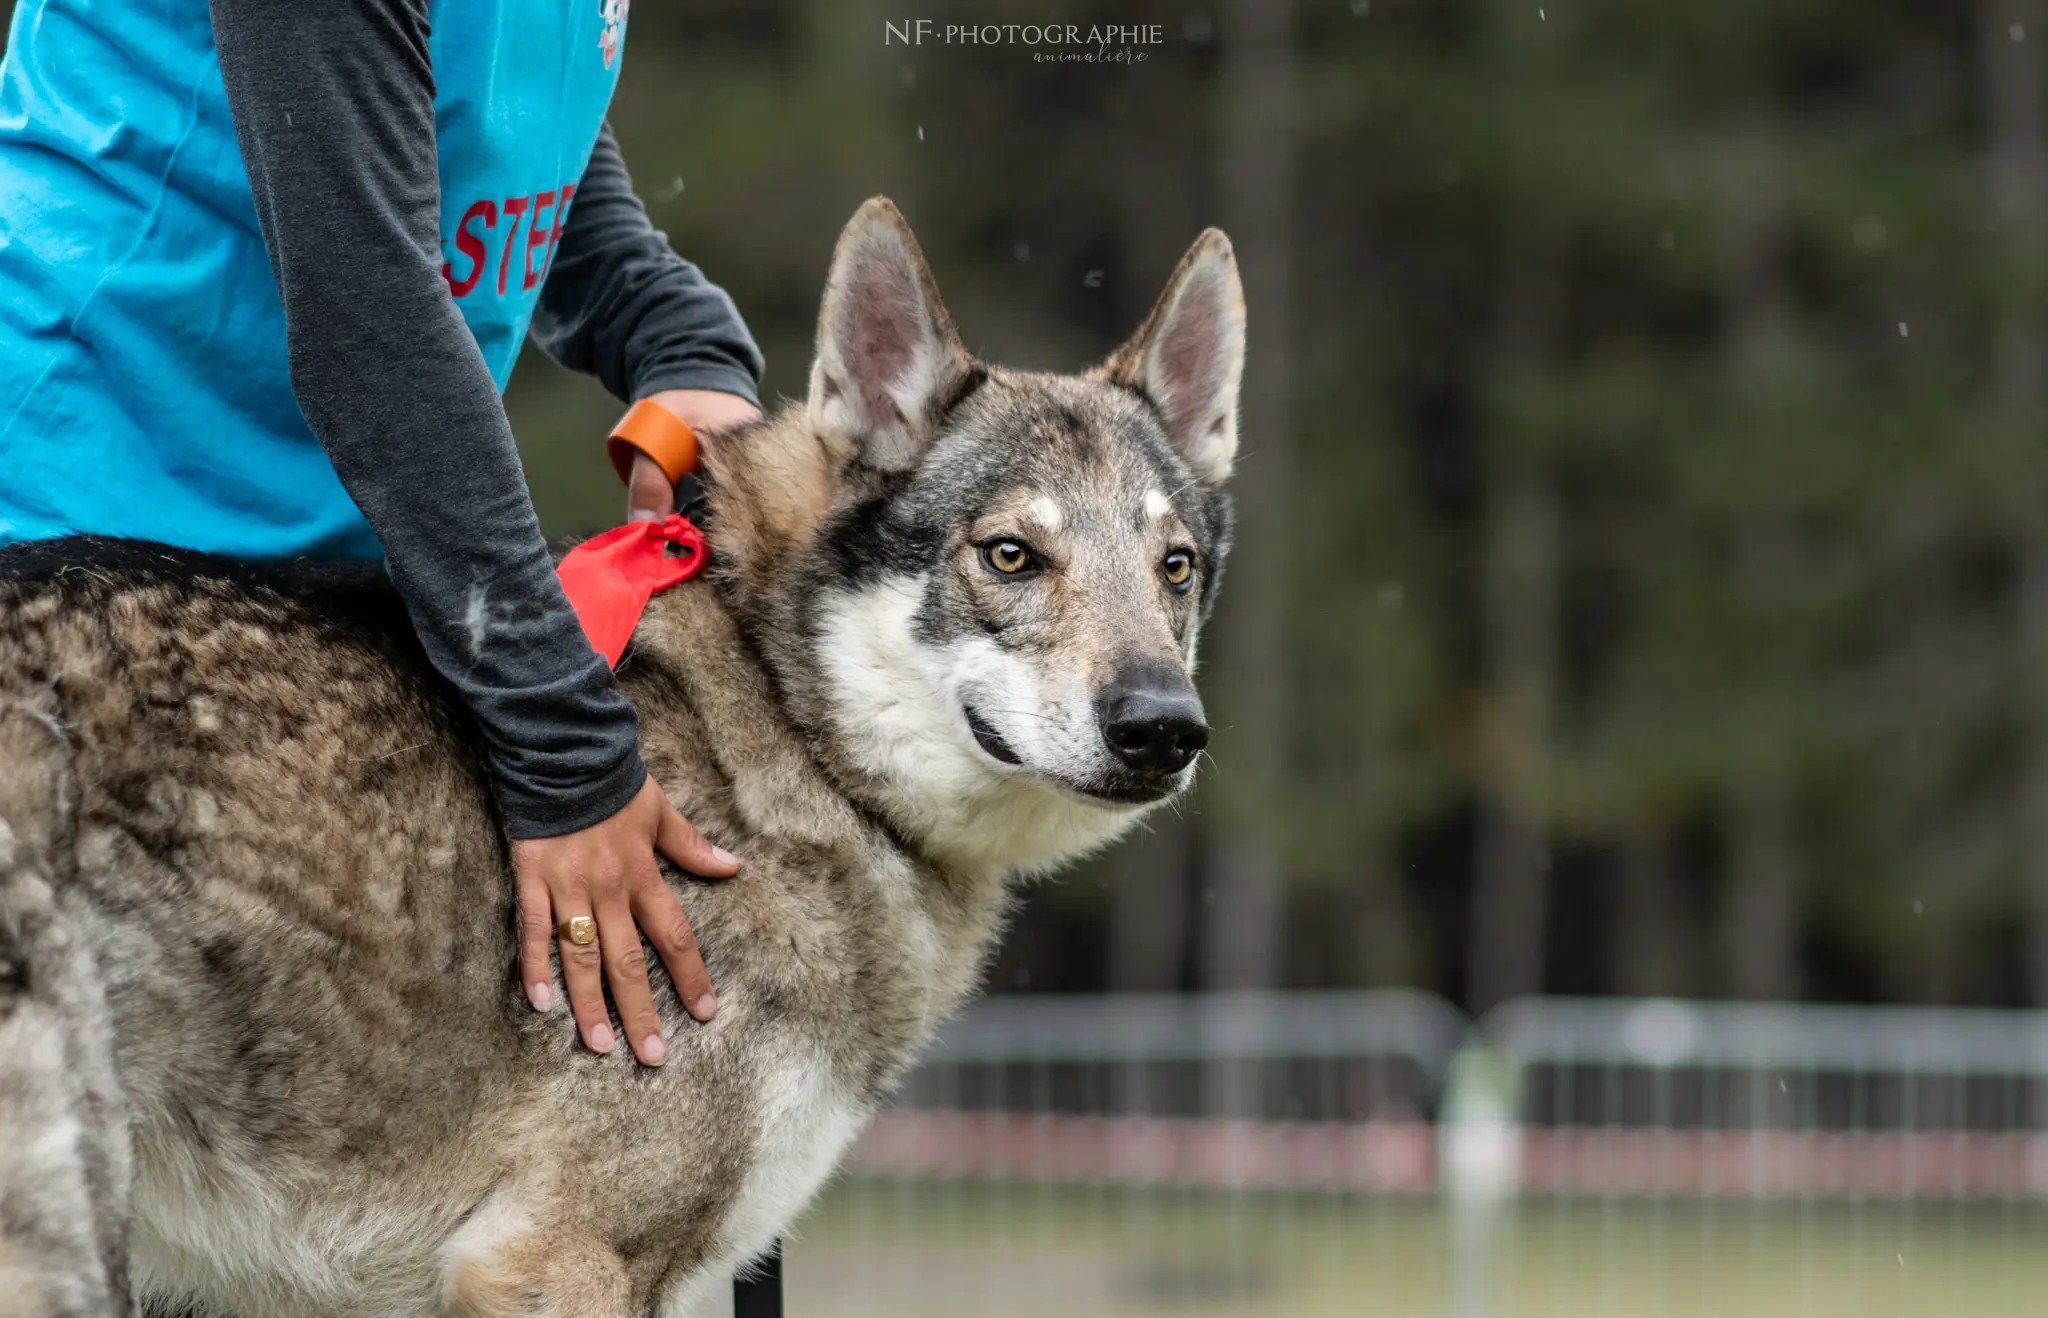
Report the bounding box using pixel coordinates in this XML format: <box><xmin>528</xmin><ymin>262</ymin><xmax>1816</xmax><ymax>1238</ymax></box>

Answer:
<box><xmin>0</xmin><ymin>0</ymin><xmax>627</xmax><ymax>557</ymax></box>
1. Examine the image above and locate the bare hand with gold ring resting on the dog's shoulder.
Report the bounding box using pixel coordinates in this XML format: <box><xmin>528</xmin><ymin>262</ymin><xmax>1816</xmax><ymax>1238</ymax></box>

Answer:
<box><xmin>512</xmin><ymin>776</ymin><xmax>739</xmax><ymax>1066</ymax></box>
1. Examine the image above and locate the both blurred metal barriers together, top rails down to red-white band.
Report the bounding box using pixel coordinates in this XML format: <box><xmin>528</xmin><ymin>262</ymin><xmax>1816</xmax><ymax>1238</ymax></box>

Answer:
<box><xmin>852</xmin><ymin>991</ymin><xmax>2048</xmax><ymax>1199</ymax></box>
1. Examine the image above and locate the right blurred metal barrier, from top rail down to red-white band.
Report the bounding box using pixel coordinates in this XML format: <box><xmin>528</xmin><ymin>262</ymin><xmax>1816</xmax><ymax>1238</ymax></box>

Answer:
<box><xmin>1475</xmin><ymin>999</ymin><xmax>2048</xmax><ymax>1199</ymax></box>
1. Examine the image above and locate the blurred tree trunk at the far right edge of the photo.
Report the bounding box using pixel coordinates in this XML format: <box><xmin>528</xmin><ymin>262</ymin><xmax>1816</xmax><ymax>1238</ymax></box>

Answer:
<box><xmin>1978</xmin><ymin>0</ymin><xmax>2048</xmax><ymax>1005</ymax></box>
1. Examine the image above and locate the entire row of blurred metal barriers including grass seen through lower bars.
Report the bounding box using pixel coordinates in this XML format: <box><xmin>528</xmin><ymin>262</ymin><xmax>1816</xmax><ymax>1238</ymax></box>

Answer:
<box><xmin>770</xmin><ymin>993</ymin><xmax>2048</xmax><ymax>1318</ymax></box>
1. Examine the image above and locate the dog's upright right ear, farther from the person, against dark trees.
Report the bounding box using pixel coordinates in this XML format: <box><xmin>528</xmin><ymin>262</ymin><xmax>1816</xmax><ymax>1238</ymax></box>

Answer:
<box><xmin>1100</xmin><ymin>229</ymin><xmax>1245</xmax><ymax>485</ymax></box>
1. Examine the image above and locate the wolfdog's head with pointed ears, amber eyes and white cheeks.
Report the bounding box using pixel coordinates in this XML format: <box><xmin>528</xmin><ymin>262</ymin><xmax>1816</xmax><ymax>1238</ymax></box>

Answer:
<box><xmin>713</xmin><ymin>199</ymin><xmax>1245</xmax><ymax>870</ymax></box>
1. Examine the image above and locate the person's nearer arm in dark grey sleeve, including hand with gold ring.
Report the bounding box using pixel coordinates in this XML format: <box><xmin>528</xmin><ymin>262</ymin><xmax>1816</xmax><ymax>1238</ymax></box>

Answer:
<box><xmin>211</xmin><ymin>0</ymin><xmax>731</xmax><ymax>1060</ymax></box>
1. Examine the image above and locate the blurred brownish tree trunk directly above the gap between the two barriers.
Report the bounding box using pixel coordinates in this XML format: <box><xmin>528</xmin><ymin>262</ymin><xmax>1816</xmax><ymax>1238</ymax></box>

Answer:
<box><xmin>1466</xmin><ymin>259</ymin><xmax>1563</xmax><ymax>1011</ymax></box>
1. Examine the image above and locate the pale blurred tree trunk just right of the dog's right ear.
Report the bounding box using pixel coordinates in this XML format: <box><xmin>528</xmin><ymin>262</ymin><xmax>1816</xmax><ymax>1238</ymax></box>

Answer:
<box><xmin>1202</xmin><ymin>0</ymin><xmax>1294</xmax><ymax>1115</ymax></box>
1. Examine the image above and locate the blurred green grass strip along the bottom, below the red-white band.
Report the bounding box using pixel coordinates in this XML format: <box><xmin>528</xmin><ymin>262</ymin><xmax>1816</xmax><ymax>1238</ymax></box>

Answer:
<box><xmin>788</xmin><ymin>1183</ymin><xmax>2048</xmax><ymax>1318</ymax></box>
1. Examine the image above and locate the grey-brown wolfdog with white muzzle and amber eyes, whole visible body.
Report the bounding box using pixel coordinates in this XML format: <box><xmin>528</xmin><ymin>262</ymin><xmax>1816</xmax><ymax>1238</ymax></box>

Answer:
<box><xmin>0</xmin><ymin>199</ymin><xmax>1245</xmax><ymax>1318</ymax></box>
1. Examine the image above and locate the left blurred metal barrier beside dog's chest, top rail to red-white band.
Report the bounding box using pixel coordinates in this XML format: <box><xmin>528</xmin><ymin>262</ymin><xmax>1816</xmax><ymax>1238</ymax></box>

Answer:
<box><xmin>852</xmin><ymin>991</ymin><xmax>1464</xmax><ymax>1191</ymax></box>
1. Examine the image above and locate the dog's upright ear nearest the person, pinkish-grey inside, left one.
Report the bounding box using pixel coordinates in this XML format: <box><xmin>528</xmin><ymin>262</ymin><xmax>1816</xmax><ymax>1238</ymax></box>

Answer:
<box><xmin>809</xmin><ymin>196</ymin><xmax>973</xmax><ymax>471</ymax></box>
